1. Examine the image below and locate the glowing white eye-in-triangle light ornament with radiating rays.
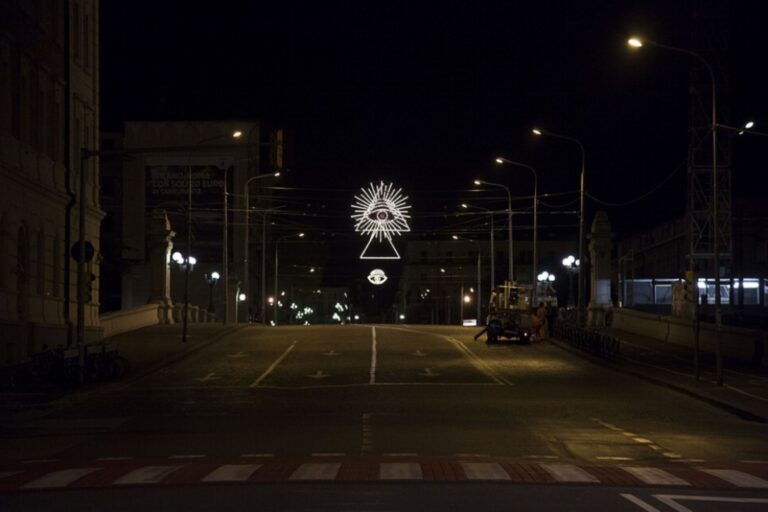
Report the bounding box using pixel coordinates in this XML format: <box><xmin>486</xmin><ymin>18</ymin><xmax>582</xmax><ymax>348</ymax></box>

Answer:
<box><xmin>352</xmin><ymin>181</ymin><xmax>411</xmax><ymax>260</ymax></box>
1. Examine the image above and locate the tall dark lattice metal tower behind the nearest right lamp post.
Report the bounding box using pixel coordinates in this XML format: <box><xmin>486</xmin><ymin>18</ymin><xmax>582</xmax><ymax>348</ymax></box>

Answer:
<box><xmin>687</xmin><ymin>0</ymin><xmax>733</xmax><ymax>277</ymax></box>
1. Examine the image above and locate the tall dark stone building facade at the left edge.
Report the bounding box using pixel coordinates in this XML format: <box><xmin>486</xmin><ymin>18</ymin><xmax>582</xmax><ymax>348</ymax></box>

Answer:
<box><xmin>0</xmin><ymin>0</ymin><xmax>103</xmax><ymax>365</ymax></box>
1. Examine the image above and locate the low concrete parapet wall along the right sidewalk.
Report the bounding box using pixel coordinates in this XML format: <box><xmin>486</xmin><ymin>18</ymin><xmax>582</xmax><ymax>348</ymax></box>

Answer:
<box><xmin>611</xmin><ymin>308</ymin><xmax>768</xmax><ymax>366</ymax></box>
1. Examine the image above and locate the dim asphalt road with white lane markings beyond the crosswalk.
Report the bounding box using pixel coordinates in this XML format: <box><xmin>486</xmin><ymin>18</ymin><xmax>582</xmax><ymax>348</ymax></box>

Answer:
<box><xmin>0</xmin><ymin>325</ymin><xmax>768</xmax><ymax>510</ymax></box>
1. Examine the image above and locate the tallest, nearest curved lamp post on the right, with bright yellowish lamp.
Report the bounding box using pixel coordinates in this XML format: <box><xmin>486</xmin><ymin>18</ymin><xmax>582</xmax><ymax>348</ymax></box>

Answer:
<box><xmin>627</xmin><ymin>37</ymin><xmax>724</xmax><ymax>386</ymax></box>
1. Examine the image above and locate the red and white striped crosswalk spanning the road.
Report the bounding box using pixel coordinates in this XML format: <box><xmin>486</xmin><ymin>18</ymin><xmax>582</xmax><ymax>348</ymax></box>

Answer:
<box><xmin>0</xmin><ymin>457</ymin><xmax>768</xmax><ymax>491</ymax></box>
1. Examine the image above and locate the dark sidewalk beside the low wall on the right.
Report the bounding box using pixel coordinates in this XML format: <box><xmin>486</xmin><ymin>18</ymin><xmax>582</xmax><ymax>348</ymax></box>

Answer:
<box><xmin>557</xmin><ymin>328</ymin><xmax>768</xmax><ymax>423</ymax></box>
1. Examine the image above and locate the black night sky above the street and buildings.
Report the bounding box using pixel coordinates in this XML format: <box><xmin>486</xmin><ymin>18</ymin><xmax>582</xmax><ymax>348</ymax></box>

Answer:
<box><xmin>101</xmin><ymin>0</ymin><xmax>768</xmax><ymax>239</ymax></box>
